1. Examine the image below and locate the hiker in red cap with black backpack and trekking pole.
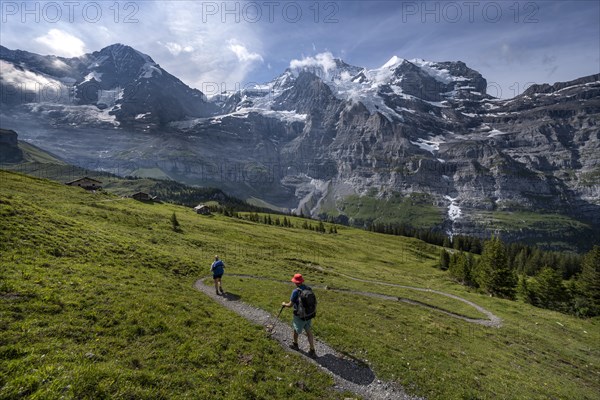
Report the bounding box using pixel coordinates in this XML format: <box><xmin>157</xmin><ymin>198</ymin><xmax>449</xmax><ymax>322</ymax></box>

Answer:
<box><xmin>281</xmin><ymin>274</ymin><xmax>317</xmax><ymax>357</ymax></box>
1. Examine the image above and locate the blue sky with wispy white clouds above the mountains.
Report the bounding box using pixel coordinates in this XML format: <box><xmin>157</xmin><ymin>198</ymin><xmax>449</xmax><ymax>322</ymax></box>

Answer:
<box><xmin>0</xmin><ymin>0</ymin><xmax>600</xmax><ymax>98</ymax></box>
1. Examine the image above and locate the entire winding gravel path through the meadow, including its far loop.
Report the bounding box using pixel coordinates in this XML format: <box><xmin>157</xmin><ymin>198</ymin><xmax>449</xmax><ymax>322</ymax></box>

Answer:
<box><xmin>194</xmin><ymin>267</ymin><xmax>502</xmax><ymax>400</ymax></box>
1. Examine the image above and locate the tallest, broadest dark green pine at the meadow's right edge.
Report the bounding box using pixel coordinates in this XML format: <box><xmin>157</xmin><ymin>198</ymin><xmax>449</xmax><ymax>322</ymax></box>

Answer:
<box><xmin>476</xmin><ymin>238</ymin><xmax>517</xmax><ymax>299</ymax></box>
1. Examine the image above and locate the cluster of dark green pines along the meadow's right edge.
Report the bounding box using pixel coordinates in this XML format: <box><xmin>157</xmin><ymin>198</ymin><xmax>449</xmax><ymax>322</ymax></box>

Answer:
<box><xmin>439</xmin><ymin>238</ymin><xmax>600</xmax><ymax>317</ymax></box>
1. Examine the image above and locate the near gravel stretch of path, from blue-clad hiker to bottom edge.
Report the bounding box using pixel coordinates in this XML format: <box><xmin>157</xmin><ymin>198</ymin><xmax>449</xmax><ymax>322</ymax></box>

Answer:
<box><xmin>194</xmin><ymin>278</ymin><xmax>422</xmax><ymax>400</ymax></box>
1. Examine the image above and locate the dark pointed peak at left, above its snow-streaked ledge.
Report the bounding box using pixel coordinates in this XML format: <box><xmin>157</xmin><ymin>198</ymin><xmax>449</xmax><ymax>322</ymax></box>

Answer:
<box><xmin>0</xmin><ymin>44</ymin><xmax>218</xmax><ymax>129</ymax></box>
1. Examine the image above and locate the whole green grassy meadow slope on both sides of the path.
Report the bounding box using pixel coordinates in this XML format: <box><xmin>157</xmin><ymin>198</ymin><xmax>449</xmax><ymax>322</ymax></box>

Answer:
<box><xmin>0</xmin><ymin>171</ymin><xmax>600</xmax><ymax>399</ymax></box>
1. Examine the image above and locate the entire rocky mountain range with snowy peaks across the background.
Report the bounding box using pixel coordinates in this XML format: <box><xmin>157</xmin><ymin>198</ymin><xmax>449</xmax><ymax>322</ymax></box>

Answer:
<box><xmin>0</xmin><ymin>45</ymin><xmax>600</xmax><ymax>247</ymax></box>
